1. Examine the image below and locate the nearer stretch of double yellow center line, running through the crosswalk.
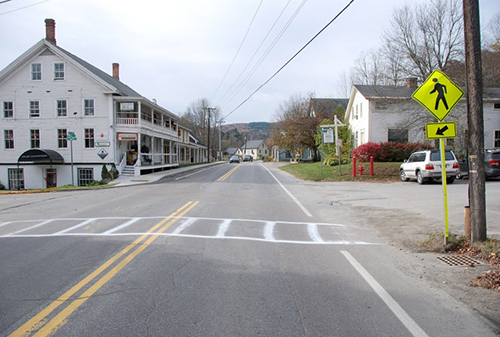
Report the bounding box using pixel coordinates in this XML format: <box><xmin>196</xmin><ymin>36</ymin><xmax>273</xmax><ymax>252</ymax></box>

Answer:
<box><xmin>9</xmin><ymin>201</ymin><xmax>198</xmax><ymax>337</ymax></box>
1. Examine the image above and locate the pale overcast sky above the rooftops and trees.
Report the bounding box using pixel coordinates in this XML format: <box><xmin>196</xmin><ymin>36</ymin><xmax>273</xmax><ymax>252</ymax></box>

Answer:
<box><xmin>0</xmin><ymin>0</ymin><xmax>500</xmax><ymax>123</ymax></box>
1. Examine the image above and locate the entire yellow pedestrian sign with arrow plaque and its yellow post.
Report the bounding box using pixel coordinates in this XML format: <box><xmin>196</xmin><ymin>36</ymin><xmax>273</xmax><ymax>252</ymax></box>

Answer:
<box><xmin>411</xmin><ymin>70</ymin><xmax>464</xmax><ymax>245</ymax></box>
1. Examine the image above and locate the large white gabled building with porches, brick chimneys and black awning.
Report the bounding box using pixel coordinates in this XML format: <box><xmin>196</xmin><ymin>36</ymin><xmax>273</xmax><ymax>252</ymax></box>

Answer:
<box><xmin>0</xmin><ymin>19</ymin><xmax>206</xmax><ymax>189</ymax></box>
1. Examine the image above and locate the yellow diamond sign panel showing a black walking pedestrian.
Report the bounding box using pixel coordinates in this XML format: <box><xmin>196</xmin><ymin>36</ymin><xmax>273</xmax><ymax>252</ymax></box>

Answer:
<box><xmin>411</xmin><ymin>70</ymin><xmax>464</xmax><ymax>121</ymax></box>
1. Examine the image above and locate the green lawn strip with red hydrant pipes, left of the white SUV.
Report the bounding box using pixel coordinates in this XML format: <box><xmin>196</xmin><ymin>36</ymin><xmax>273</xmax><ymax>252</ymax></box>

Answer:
<box><xmin>280</xmin><ymin>162</ymin><xmax>401</xmax><ymax>182</ymax></box>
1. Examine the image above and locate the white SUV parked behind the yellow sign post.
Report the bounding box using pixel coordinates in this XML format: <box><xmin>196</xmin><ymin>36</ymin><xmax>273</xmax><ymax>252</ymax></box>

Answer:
<box><xmin>399</xmin><ymin>149</ymin><xmax>460</xmax><ymax>185</ymax></box>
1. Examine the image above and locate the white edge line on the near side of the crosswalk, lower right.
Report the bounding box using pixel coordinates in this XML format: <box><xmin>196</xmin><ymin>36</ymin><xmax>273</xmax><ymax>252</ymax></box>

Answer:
<box><xmin>340</xmin><ymin>250</ymin><xmax>429</xmax><ymax>337</ymax></box>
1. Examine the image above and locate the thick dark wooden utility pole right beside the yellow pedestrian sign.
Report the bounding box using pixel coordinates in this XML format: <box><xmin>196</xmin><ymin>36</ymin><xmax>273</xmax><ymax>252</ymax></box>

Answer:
<box><xmin>463</xmin><ymin>0</ymin><xmax>486</xmax><ymax>242</ymax></box>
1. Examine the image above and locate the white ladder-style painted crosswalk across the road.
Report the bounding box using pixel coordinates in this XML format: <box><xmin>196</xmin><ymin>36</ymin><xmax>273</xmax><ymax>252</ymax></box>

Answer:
<box><xmin>0</xmin><ymin>216</ymin><xmax>376</xmax><ymax>245</ymax></box>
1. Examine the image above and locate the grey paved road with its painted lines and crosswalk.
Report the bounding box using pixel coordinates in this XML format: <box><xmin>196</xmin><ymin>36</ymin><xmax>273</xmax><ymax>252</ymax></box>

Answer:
<box><xmin>0</xmin><ymin>162</ymin><xmax>495</xmax><ymax>336</ymax></box>
